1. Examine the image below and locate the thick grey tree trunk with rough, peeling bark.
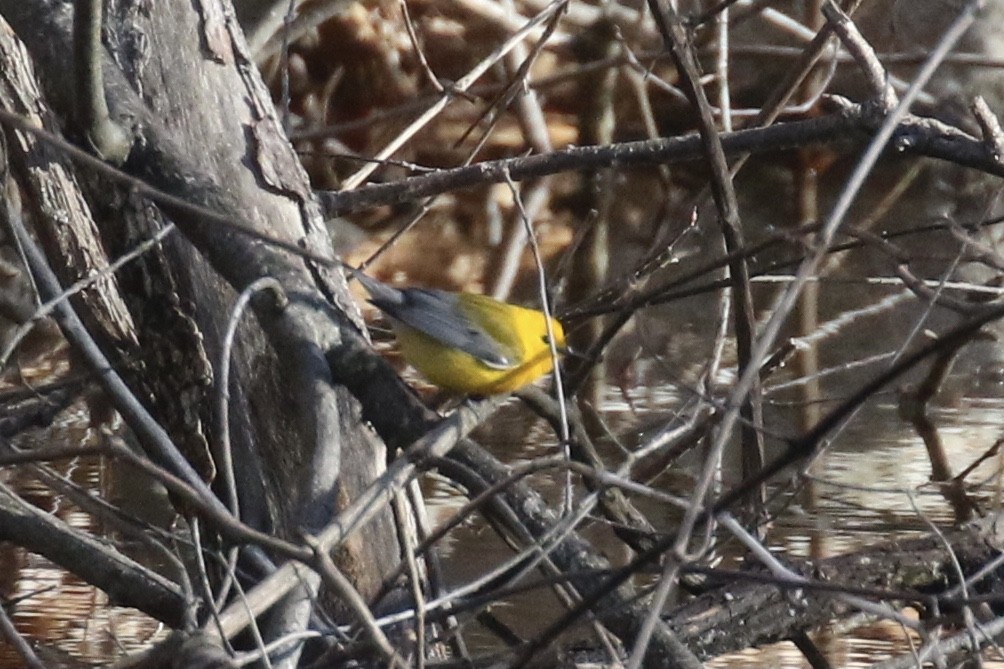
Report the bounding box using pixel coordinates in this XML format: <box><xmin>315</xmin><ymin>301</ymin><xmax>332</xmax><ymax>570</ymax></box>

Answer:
<box><xmin>0</xmin><ymin>0</ymin><xmax>399</xmax><ymax>646</ymax></box>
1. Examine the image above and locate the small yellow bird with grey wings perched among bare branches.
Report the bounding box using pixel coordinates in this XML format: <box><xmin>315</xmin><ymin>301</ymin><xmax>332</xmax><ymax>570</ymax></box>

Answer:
<box><xmin>352</xmin><ymin>271</ymin><xmax>565</xmax><ymax>395</ymax></box>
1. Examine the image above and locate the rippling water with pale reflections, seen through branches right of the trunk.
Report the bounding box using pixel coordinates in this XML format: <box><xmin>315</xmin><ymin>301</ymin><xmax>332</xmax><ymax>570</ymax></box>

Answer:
<box><xmin>429</xmin><ymin>339</ymin><xmax>1004</xmax><ymax>667</ymax></box>
